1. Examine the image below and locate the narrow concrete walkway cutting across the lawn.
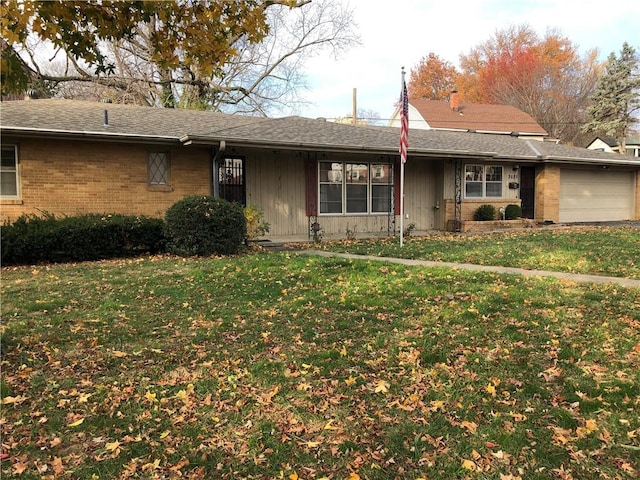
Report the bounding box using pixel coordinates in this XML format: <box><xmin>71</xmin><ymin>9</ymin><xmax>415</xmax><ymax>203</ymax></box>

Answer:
<box><xmin>297</xmin><ymin>250</ymin><xmax>640</xmax><ymax>288</ymax></box>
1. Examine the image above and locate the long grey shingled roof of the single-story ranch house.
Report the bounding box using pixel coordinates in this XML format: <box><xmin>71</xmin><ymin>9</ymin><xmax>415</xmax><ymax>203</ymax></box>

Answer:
<box><xmin>0</xmin><ymin>99</ymin><xmax>640</xmax><ymax>165</ymax></box>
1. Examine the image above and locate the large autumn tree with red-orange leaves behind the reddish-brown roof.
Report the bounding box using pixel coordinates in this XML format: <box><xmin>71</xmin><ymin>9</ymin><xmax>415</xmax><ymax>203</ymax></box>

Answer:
<box><xmin>457</xmin><ymin>25</ymin><xmax>601</xmax><ymax>143</ymax></box>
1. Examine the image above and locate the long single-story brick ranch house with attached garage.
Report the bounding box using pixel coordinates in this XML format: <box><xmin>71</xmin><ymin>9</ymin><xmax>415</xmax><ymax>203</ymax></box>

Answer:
<box><xmin>0</xmin><ymin>100</ymin><xmax>640</xmax><ymax>240</ymax></box>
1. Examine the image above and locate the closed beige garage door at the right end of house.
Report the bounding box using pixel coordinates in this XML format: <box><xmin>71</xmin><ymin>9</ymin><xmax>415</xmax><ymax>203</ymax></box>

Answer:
<box><xmin>560</xmin><ymin>169</ymin><xmax>633</xmax><ymax>222</ymax></box>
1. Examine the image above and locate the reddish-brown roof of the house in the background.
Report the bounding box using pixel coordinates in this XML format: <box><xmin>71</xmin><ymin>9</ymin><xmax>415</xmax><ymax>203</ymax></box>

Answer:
<box><xmin>409</xmin><ymin>98</ymin><xmax>547</xmax><ymax>136</ymax></box>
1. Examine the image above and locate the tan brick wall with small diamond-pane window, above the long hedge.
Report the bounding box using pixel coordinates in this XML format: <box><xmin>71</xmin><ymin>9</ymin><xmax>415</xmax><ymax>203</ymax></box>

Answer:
<box><xmin>0</xmin><ymin>140</ymin><xmax>211</xmax><ymax>222</ymax></box>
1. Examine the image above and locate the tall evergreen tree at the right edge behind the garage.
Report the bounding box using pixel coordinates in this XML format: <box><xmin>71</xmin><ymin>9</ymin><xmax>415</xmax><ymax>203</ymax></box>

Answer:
<box><xmin>582</xmin><ymin>42</ymin><xmax>640</xmax><ymax>154</ymax></box>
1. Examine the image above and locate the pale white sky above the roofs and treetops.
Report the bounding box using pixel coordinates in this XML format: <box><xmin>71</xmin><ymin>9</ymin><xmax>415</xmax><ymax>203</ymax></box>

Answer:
<box><xmin>297</xmin><ymin>0</ymin><xmax>640</xmax><ymax>119</ymax></box>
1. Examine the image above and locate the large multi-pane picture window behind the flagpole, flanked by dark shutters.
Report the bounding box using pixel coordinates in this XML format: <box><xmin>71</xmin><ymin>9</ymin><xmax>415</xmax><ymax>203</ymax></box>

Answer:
<box><xmin>318</xmin><ymin>162</ymin><xmax>393</xmax><ymax>215</ymax></box>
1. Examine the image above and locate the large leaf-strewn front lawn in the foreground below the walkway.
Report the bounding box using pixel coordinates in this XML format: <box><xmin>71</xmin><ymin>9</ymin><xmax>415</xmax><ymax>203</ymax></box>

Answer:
<box><xmin>0</xmin><ymin>231</ymin><xmax>640</xmax><ymax>479</ymax></box>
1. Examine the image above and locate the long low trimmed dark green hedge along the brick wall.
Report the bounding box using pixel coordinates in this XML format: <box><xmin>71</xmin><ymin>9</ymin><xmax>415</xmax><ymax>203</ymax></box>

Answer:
<box><xmin>1</xmin><ymin>213</ymin><xmax>165</xmax><ymax>265</ymax></box>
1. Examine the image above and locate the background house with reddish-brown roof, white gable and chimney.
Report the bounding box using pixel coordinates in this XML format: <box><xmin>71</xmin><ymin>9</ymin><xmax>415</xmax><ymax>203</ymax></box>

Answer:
<box><xmin>389</xmin><ymin>91</ymin><xmax>548</xmax><ymax>140</ymax></box>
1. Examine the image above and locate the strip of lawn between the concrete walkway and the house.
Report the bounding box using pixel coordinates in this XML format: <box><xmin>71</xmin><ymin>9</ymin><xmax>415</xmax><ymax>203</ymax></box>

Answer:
<box><xmin>305</xmin><ymin>227</ymin><xmax>640</xmax><ymax>279</ymax></box>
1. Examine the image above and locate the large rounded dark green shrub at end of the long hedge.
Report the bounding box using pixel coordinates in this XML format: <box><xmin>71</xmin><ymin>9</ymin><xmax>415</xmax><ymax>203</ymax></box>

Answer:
<box><xmin>165</xmin><ymin>195</ymin><xmax>247</xmax><ymax>256</ymax></box>
